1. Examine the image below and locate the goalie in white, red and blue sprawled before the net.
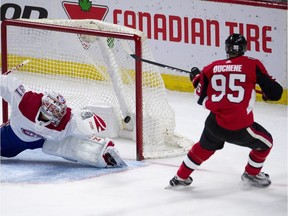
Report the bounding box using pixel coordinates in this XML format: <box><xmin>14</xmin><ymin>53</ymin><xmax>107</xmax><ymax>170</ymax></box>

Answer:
<box><xmin>0</xmin><ymin>72</ymin><xmax>126</xmax><ymax>168</ymax></box>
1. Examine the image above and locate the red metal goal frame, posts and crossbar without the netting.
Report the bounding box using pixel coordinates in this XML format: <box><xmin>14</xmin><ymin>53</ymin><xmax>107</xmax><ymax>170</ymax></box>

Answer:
<box><xmin>1</xmin><ymin>19</ymin><xmax>144</xmax><ymax>161</ymax></box>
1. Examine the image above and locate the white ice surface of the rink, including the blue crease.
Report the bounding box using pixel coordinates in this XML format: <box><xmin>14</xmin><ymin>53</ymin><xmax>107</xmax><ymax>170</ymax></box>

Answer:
<box><xmin>0</xmin><ymin>92</ymin><xmax>288</xmax><ymax>216</ymax></box>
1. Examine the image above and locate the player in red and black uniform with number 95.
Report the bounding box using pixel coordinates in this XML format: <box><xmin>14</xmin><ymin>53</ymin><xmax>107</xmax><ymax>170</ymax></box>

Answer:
<box><xmin>169</xmin><ymin>34</ymin><xmax>283</xmax><ymax>187</ymax></box>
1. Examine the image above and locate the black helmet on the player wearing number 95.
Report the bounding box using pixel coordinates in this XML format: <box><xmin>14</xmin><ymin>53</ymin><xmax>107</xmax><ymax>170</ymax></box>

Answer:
<box><xmin>225</xmin><ymin>33</ymin><xmax>247</xmax><ymax>55</ymax></box>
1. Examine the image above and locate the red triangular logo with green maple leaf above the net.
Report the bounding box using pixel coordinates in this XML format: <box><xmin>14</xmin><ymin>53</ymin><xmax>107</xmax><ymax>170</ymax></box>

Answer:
<box><xmin>62</xmin><ymin>0</ymin><xmax>109</xmax><ymax>21</ymax></box>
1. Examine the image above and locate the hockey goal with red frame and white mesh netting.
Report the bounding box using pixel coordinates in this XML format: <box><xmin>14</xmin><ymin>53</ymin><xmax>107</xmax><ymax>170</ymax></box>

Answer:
<box><xmin>2</xmin><ymin>19</ymin><xmax>193</xmax><ymax>160</ymax></box>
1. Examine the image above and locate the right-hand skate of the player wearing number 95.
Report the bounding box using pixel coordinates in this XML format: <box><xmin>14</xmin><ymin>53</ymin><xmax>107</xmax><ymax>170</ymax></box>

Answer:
<box><xmin>241</xmin><ymin>172</ymin><xmax>271</xmax><ymax>188</ymax></box>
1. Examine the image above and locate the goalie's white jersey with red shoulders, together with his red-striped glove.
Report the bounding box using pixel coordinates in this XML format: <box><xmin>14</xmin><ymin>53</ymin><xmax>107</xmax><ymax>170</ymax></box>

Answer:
<box><xmin>1</xmin><ymin>75</ymin><xmax>106</xmax><ymax>142</ymax></box>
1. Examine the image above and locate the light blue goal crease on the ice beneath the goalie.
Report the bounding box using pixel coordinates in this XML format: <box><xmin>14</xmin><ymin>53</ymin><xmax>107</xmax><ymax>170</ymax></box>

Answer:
<box><xmin>0</xmin><ymin>150</ymin><xmax>148</xmax><ymax>184</ymax></box>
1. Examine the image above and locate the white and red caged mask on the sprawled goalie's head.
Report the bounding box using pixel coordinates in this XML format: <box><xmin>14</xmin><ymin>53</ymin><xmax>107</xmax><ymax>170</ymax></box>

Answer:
<box><xmin>40</xmin><ymin>92</ymin><xmax>67</xmax><ymax>126</ymax></box>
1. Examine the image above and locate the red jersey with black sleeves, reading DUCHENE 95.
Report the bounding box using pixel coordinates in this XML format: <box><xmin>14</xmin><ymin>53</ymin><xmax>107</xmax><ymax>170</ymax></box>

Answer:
<box><xmin>196</xmin><ymin>56</ymin><xmax>283</xmax><ymax>130</ymax></box>
